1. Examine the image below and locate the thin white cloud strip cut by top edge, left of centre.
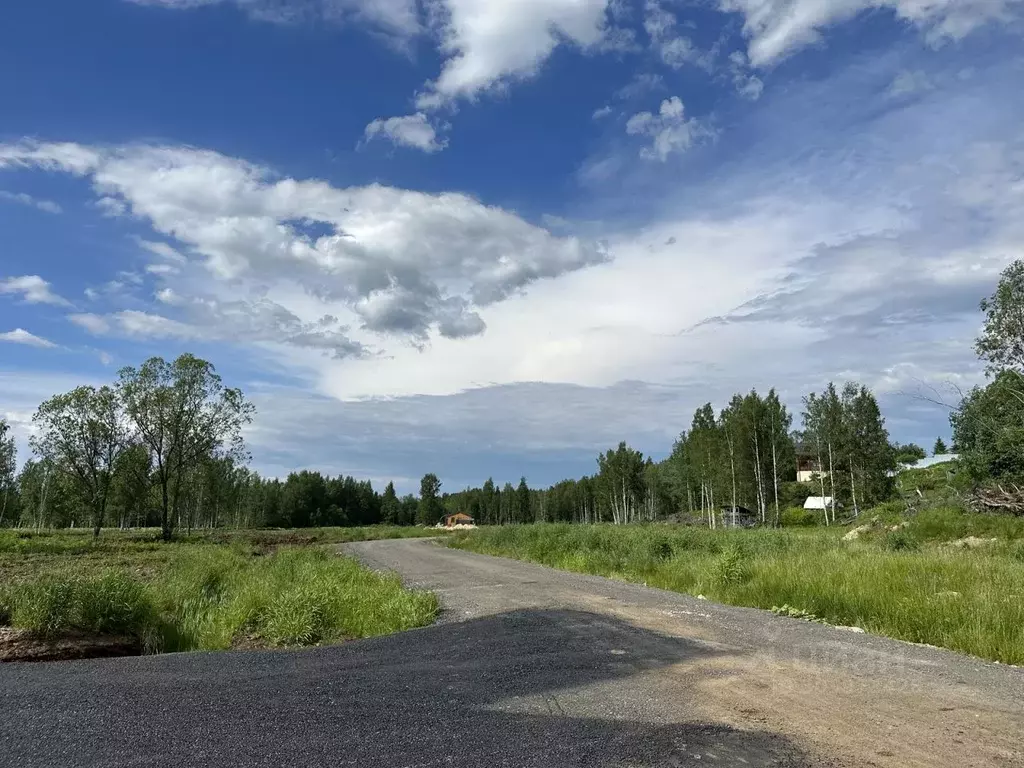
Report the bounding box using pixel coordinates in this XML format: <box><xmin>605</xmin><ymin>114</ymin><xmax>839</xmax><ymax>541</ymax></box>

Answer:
<box><xmin>127</xmin><ymin>0</ymin><xmax>421</xmax><ymax>38</ymax></box>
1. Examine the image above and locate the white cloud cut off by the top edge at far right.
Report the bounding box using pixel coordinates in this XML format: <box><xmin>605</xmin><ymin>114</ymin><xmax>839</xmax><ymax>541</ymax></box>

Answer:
<box><xmin>718</xmin><ymin>0</ymin><xmax>1024</xmax><ymax>67</ymax></box>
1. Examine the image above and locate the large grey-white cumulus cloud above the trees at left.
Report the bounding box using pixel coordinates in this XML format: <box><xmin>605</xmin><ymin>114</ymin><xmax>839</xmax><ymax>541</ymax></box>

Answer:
<box><xmin>0</xmin><ymin>142</ymin><xmax>607</xmax><ymax>354</ymax></box>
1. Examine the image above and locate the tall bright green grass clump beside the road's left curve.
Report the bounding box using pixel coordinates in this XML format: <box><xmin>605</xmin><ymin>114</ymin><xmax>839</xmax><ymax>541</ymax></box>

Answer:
<box><xmin>0</xmin><ymin>546</ymin><xmax>437</xmax><ymax>651</ymax></box>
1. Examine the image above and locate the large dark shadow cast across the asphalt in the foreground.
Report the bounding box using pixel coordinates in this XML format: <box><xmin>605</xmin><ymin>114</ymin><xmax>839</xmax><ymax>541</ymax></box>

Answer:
<box><xmin>0</xmin><ymin>610</ymin><xmax>820</xmax><ymax>768</ymax></box>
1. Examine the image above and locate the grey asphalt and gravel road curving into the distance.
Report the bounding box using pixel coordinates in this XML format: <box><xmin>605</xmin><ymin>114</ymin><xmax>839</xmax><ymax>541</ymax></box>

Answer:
<box><xmin>0</xmin><ymin>540</ymin><xmax>1024</xmax><ymax>768</ymax></box>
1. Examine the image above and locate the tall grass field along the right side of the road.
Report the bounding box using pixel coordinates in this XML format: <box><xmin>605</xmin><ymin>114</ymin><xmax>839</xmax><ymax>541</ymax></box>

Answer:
<box><xmin>450</xmin><ymin>518</ymin><xmax>1024</xmax><ymax>665</ymax></box>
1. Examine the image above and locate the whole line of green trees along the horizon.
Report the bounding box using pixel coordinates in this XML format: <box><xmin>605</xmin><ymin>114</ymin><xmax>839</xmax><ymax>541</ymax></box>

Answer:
<box><xmin>0</xmin><ymin>261</ymin><xmax>1024</xmax><ymax>539</ymax></box>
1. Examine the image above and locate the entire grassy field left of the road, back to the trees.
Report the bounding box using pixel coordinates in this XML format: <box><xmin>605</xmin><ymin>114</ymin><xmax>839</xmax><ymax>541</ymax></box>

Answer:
<box><xmin>0</xmin><ymin>526</ymin><xmax>437</xmax><ymax>652</ymax></box>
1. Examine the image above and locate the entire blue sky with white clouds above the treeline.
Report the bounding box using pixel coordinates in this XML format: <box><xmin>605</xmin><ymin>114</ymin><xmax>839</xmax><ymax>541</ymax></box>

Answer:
<box><xmin>0</xmin><ymin>0</ymin><xmax>1024</xmax><ymax>489</ymax></box>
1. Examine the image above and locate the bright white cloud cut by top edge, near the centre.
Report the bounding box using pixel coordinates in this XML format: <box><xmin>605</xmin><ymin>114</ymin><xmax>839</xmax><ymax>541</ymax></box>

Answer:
<box><xmin>417</xmin><ymin>0</ymin><xmax>608</xmax><ymax>110</ymax></box>
